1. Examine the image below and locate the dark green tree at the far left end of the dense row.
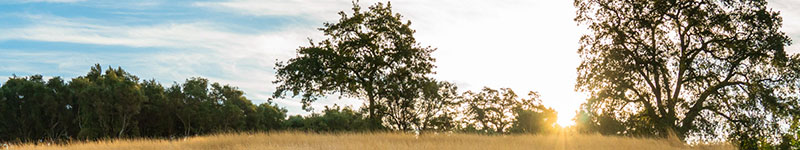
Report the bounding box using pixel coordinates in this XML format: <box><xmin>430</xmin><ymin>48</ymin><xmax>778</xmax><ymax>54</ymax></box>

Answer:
<box><xmin>0</xmin><ymin>75</ymin><xmax>72</xmax><ymax>140</ymax></box>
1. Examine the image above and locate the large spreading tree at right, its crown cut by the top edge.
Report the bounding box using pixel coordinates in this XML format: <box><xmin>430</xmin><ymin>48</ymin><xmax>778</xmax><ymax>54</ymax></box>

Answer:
<box><xmin>575</xmin><ymin>0</ymin><xmax>798</xmax><ymax>145</ymax></box>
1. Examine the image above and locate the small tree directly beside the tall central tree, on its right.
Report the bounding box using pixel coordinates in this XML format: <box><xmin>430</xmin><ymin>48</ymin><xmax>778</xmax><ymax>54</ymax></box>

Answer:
<box><xmin>378</xmin><ymin>78</ymin><xmax>458</xmax><ymax>131</ymax></box>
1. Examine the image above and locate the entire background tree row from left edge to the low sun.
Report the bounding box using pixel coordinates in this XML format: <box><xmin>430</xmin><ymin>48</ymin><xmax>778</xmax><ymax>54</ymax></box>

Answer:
<box><xmin>0</xmin><ymin>64</ymin><xmax>556</xmax><ymax>142</ymax></box>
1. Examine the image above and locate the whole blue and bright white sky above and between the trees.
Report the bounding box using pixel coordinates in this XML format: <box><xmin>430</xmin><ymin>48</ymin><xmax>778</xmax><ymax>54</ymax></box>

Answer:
<box><xmin>0</xmin><ymin>0</ymin><xmax>800</xmax><ymax>125</ymax></box>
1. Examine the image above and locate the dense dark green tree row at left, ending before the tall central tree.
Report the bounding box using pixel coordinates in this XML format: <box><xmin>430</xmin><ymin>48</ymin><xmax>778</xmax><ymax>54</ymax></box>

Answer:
<box><xmin>0</xmin><ymin>65</ymin><xmax>286</xmax><ymax>141</ymax></box>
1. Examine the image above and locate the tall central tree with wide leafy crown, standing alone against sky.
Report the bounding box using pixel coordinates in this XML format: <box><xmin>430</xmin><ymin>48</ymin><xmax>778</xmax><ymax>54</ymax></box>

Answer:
<box><xmin>274</xmin><ymin>3</ymin><xmax>435</xmax><ymax>127</ymax></box>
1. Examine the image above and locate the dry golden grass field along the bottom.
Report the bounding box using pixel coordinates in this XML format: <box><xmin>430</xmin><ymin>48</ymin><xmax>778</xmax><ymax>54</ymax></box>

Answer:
<box><xmin>6</xmin><ymin>132</ymin><xmax>735</xmax><ymax>150</ymax></box>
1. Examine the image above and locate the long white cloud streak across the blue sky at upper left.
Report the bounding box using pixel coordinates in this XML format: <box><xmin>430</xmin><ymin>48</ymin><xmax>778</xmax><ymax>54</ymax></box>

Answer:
<box><xmin>0</xmin><ymin>16</ymin><xmax>294</xmax><ymax>54</ymax></box>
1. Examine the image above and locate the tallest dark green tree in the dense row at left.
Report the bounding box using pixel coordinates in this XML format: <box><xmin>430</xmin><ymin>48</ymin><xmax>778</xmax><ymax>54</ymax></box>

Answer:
<box><xmin>70</xmin><ymin>64</ymin><xmax>147</xmax><ymax>138</ymax></box>
